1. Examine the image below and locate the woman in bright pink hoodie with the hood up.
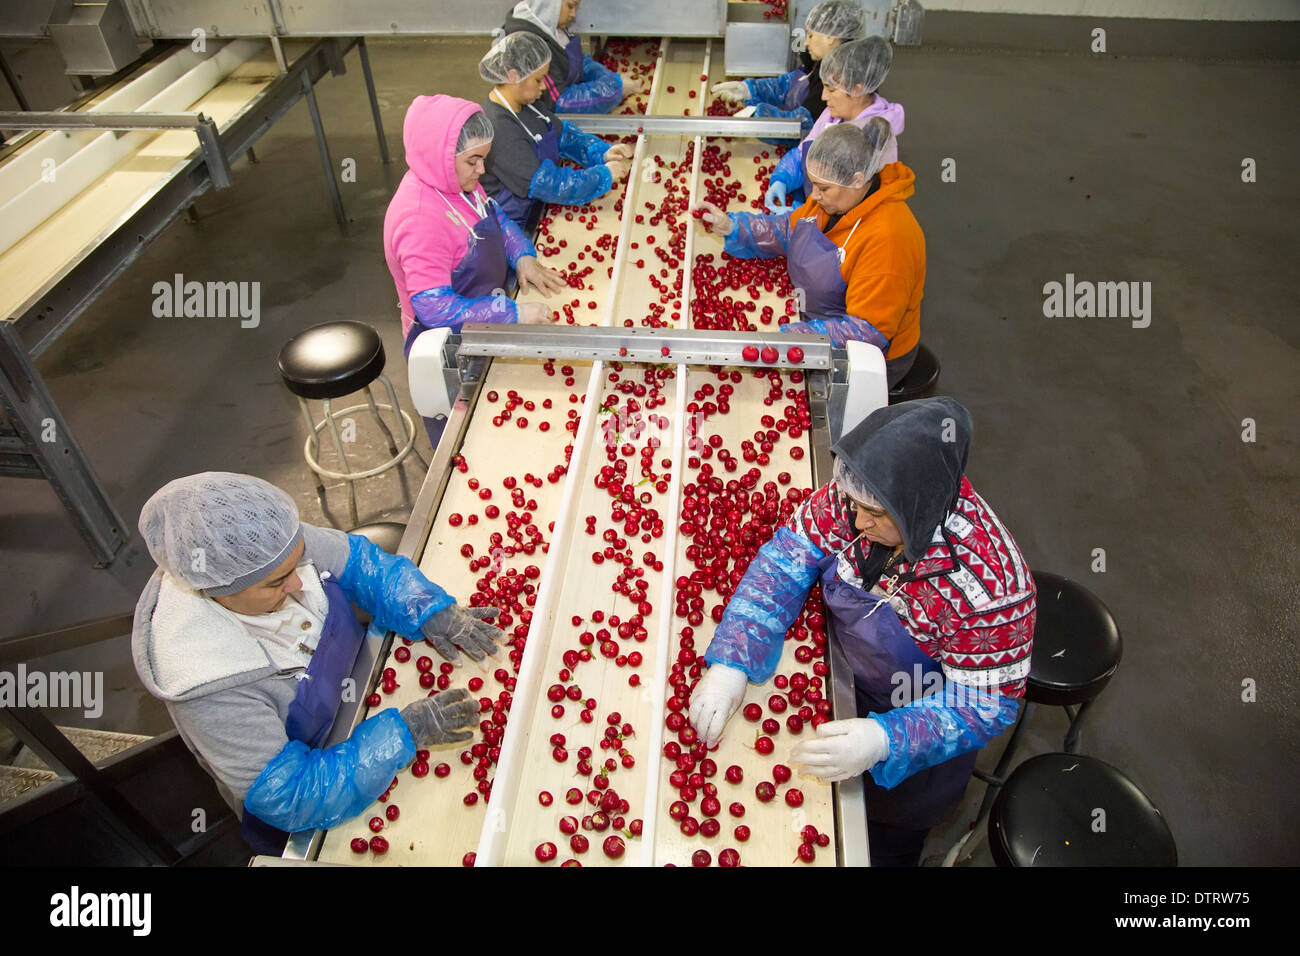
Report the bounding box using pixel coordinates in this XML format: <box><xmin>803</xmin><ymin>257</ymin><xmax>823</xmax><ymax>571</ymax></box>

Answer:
<box><xmin>384</xmin><ymin>95</ymin><xmax>564</xmax><ymax>355</ymax></box>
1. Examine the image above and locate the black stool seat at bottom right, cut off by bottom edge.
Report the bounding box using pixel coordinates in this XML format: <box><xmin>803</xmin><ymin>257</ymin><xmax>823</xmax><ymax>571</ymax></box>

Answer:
<box><xmin>988</xmin><ymin>753</ymin><xmax>1178</xmax><ymax>866</ymax></box>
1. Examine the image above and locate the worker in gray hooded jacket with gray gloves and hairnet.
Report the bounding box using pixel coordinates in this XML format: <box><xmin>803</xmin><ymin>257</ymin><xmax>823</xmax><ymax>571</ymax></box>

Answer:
<box><xmin>131</xmin><ymin>472</ymin><xmax>501</xmax><ymax>853</ymax></box>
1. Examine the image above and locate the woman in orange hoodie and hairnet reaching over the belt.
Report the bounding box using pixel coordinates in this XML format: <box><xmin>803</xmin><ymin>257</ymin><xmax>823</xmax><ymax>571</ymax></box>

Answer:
<box><xmin>698</xmin><ymin>117</ymin><xmax>926</xmax><ymax>388</ymax></box>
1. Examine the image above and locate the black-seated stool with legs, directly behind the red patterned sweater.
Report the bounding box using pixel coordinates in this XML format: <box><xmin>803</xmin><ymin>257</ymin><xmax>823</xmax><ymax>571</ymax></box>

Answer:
<box><xmin>946</xmin><ymin>571</ymin><xmax>1123</xmax><ymax>865</ymax></box>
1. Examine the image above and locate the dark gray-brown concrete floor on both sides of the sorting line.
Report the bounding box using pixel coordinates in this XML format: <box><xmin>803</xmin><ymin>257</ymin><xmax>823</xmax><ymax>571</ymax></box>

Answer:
<box><xmin>0</xmin><ymin>40</ymin><xmax>1300</xmax><ymax>865</ymax></box>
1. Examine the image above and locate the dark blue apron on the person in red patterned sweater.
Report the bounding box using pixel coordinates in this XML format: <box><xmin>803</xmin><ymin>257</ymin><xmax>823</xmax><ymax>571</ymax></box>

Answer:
<box><xmin>819</xmin><ymin>554</ymin><xmax>979</xmax><ymax>830</ymax></box>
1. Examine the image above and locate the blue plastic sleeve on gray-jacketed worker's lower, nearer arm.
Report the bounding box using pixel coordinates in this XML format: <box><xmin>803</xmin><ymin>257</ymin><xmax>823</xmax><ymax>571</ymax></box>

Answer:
<box><xmin>244</xmin><ymin>708</ymin><xmax>416</xmax><ymax>832</ymax></box>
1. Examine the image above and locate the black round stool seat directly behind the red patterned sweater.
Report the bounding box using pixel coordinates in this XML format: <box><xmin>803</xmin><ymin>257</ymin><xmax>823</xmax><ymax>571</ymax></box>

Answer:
<box><xmin>1024</xmin><ymin>571</ymin><xmax>1122</xmax><ymax>706</ymax></box>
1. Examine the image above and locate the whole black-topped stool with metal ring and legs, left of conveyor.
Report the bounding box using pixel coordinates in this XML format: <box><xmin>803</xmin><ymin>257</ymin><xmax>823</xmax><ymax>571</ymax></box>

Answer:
<box><xmin>277</xmin><ymin>321</ymin><xmax>424</xmax><ymax>525</ymax></box>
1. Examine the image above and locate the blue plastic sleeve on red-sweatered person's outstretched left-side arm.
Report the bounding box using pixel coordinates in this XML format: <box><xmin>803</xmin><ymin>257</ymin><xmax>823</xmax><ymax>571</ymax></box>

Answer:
<box><xmin>705</xmin><ymin>527</ymin><xmax>823</xmax><ymax>684</ymax></box>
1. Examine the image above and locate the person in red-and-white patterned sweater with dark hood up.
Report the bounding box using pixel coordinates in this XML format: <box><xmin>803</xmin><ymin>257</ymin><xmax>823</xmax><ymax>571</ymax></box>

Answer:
<box><xmin>689</xmin><ymin>397</ymin><xmax>1036</xmax><ymax>866</ymax></box>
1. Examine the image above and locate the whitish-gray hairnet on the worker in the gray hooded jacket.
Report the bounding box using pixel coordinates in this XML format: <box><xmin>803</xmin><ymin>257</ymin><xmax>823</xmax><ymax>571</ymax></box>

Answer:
<box><xmin>139</xmin><ymin>471</ymin><xmax>303</xmax><ymax>597</ymax></box>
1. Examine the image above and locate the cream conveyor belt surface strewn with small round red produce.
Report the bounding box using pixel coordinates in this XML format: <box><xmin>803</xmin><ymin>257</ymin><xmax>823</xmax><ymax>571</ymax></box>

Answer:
<box><xmin>299</xmin><ymin>40</ymin><xmax>862</xmax><ymax>865</ymax></box>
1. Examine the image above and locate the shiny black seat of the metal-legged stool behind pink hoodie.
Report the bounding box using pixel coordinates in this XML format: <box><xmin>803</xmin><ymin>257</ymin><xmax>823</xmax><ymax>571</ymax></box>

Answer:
<box><xmin>278</xmin><ymin>321</ymin><xmax>384</xmax><ymax>398</ymax></box>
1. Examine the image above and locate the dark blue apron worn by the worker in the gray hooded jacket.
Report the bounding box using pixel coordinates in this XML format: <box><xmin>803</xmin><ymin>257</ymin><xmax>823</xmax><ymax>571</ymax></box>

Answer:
<box><xmin>239</xmin><ymin>578</ymin><xmax>365</xmax><ymax>856</ymax></box>
